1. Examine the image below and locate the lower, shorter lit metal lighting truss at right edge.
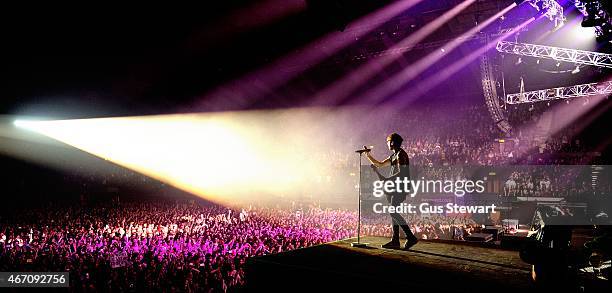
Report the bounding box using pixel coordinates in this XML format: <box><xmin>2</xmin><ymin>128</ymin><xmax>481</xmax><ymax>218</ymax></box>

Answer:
<box><xmin>506</xmin><ymin>81</ymin><xmax>612</xmax><ymax>104</ymax></box>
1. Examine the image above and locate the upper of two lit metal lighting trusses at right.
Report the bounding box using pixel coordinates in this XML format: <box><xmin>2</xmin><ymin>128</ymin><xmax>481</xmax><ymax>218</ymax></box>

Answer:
<box><xmin>496</xmin><ymin>41</ymin><xmax>612</xmax><ymax>68</ymax></box>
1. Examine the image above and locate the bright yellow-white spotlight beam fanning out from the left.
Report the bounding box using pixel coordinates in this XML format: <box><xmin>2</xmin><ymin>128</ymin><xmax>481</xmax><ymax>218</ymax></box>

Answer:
<box><xmin>14</xmin><ymin>111</ymin><xmax>334</xmax><ymax>203</ymax></box>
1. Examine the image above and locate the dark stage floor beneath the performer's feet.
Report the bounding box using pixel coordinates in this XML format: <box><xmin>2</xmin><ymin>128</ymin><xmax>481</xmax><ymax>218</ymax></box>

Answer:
<box><xmin>246</xmin><ymin>237</ymin><xmax>531</xmax><ymax>292</ymax></box>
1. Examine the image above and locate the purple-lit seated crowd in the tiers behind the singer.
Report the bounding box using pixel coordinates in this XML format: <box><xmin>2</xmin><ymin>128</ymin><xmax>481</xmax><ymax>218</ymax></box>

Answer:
<box><xmin>354</xmin><ymin>105</ymin><xmax>597</xmax><ymax>166</ymax></box>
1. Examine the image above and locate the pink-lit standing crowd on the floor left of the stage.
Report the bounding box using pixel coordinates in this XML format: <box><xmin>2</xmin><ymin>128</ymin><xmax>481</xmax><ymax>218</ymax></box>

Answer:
<box><xmin>0</xmin><ymin>201</ymin><xmax>357</xmax><ymax>292</ymax></box>
